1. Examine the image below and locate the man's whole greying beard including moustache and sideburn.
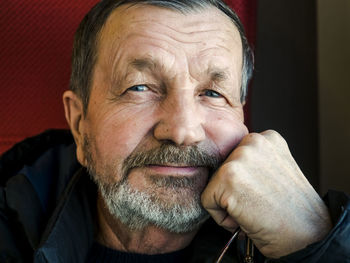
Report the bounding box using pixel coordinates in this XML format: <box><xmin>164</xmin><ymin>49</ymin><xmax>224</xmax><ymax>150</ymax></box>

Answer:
<box><xmin>83</xmin><ymin>136</ymin><xmax>220</xmax><ymax>233</ymax></box>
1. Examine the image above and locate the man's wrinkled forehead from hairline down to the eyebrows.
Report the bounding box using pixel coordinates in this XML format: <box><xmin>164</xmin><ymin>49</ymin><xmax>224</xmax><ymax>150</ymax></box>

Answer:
<box><xmin>91</xmin><ymin>2</ymin><xmax>243</xmax><ymax>93</ymax></box>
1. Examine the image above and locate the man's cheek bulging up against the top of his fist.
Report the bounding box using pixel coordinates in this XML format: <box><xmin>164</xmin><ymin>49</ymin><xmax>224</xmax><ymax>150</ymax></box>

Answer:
<box><xmin>206</xmin><ymin>111</ymin><xmax>248</xmax><ymax>159</ymax></box>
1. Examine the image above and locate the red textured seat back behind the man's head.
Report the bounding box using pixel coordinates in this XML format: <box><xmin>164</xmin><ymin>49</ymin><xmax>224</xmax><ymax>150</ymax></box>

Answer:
<box><xmin>0</xmin><ymin>0</ymin><xmax>256</xmax><ymax>154</ymax></box>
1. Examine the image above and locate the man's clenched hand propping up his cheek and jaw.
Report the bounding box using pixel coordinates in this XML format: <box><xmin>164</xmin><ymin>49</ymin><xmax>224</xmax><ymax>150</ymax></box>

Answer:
<box><xmin>202</xmin><ymin>131</ymin><xmax>332</xmax><ymax>258</ymax></box>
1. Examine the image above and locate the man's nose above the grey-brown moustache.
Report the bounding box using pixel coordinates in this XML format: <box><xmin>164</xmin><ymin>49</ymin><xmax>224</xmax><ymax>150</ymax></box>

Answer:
<box><xmin>154</xmin><ymin>92</ymin><xmax>205</xmax><ymax>146</ymax></box>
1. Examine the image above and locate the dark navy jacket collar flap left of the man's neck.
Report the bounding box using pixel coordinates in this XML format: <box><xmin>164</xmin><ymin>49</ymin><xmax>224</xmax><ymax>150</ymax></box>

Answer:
<box><xmin>34</xmin><ymin>168</ymin><xmax>96</xmax><ymax>263</ymax></box>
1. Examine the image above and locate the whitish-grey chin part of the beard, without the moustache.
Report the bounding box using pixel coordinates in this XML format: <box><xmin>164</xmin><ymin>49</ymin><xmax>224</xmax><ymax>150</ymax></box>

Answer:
<box><xmin>98</xmin><ymin>178</ymin><xmax>209</xmax><ymax>233</ymax></box>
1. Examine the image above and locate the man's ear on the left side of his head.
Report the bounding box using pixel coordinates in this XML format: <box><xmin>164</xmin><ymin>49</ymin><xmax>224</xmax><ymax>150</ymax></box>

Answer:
<box><xmin>63</xmin><ymin>90</ymin><xmax>85</xmax><ymax>165</ymax></box>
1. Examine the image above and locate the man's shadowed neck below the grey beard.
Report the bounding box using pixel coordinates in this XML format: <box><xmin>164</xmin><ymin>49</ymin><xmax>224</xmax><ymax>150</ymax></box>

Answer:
<box><xmin>97</xmin><ymin>195</ymin><xmax>197</xmax><ymax>255</ymax></box>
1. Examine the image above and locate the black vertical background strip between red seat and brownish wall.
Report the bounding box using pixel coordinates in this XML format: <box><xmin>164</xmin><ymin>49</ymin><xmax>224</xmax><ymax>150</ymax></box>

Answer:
<box><xmin>251</xmin><ymin>0</ymin><xmax>319</xmax><ymax>188</ymax></box>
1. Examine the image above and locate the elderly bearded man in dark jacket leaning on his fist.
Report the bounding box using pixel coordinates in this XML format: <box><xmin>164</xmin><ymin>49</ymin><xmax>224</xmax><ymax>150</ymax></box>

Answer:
<box><xmin>0</xmin><ymin>0</ymin><xmax>350</xmax><ymax>263</ymax></box>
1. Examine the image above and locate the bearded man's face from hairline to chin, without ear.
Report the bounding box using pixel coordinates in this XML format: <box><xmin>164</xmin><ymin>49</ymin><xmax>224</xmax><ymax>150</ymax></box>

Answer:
<box><xmin>78</xmin><ymin>5</ymin><xmax>247</xmax><ymax>232</ymax></box>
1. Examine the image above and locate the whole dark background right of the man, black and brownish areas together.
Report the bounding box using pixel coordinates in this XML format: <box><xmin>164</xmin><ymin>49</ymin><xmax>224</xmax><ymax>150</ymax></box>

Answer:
<box><xmin>250</xmin><ymin>0</ymin><xmax>350</xmax><ymax>194</ymax></box>
